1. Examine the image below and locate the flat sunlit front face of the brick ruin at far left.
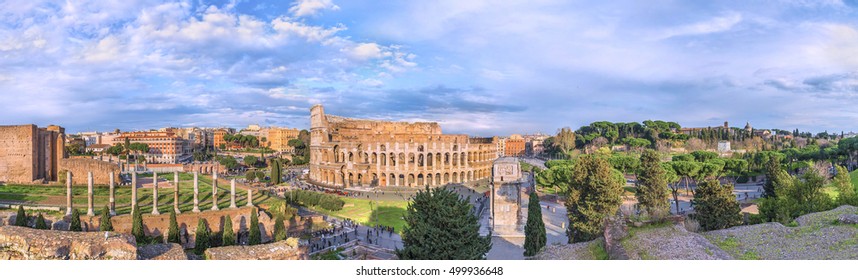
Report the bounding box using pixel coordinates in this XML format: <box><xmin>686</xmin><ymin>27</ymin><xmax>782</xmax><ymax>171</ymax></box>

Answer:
<box><xmin>0</xmin><ymin>125</ymin><xmax>38</xmax><ymax>183</ymax></box>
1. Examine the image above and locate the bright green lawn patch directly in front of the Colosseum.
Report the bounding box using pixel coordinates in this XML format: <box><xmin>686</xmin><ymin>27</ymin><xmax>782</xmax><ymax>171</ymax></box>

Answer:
<box><xmin>311</xmin><ymin>197</ymin><xmax>408</xmax><ymax>233</ymax></box>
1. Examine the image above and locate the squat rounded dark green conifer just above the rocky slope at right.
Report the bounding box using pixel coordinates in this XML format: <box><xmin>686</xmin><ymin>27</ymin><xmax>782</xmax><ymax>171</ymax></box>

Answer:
<box><xmin>694</xmin><ymin>180</ymin><xmax>742</xmax><ymax>230</ymax></box>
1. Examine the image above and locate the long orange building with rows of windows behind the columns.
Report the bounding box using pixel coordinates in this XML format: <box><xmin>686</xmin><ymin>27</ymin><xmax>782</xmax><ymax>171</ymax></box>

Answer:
<box><xmin>113</xmin><ymin>131</ymin><xmax>189</xmax><ymax>163</ymax></box>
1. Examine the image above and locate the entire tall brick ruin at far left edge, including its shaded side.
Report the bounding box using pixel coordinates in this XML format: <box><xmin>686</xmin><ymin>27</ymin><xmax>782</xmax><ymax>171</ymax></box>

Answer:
<box><xmin>0</xmin><ymin>124</ymin><xmax>66</xmax><ymax>183</ymax></box>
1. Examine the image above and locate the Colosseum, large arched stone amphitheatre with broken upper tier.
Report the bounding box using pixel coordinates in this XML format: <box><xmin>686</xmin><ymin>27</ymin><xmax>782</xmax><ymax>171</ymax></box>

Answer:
<box><xmin>310</xmin><ymin>105</ymin><xmax>497</xmax><ymax>188</ymax></box>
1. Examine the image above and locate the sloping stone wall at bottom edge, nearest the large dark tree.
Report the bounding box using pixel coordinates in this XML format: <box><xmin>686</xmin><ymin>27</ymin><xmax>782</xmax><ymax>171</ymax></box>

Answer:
<box><xmin>205</xmin><ymin>238</ymin><xmax>307</xmax><ymax>260</ymax></box>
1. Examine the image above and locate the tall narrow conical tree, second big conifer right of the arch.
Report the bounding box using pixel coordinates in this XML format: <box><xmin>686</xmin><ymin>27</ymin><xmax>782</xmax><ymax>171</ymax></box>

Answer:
<box><xmin>635</xmin><ymin>149</ymin><xmax>670</xmax><ymax>217</ymax></box>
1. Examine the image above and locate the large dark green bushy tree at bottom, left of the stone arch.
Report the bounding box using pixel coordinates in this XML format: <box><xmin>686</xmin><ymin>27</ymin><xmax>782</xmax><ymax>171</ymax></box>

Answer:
<box><xmin>396</xmin><ymin>187</ymin><xmax>492</xmax><ymax>260</ymax></box>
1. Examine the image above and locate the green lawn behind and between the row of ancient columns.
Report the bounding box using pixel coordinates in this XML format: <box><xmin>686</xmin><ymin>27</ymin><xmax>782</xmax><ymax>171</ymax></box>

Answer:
<box><xmin>0</xmin><ymin>173</ymin><xmax>273</xmax><ymax>214</ymax></box>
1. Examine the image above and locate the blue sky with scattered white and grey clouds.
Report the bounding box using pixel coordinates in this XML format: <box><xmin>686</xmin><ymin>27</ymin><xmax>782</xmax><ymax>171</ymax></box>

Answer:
<box><xmin>0</xmin><ymin>0</ymin><xmax>858</xmax><ymax>136</ymax></box>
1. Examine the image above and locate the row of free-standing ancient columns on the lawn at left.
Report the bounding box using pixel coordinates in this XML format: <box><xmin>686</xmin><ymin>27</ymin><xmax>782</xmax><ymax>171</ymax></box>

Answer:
<box><xmin>66</xmin><ymin>171</ymin><xmax>253</xmax><ymax>216</ymax></box>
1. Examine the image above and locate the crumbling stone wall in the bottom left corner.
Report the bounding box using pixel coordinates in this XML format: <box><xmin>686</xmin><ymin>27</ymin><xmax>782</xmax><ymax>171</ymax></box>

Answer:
<box><xmin>0</xmin><ymin>226</ymin><xmax>137</xmax><ymax>260</ymax></box>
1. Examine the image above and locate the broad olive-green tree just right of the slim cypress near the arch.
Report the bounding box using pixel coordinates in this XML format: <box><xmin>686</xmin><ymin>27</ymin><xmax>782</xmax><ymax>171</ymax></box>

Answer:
<box><xmin>566</xmin><ymin>155</ymin><xmax>625</xmax><ymax>243</ymax></box>
